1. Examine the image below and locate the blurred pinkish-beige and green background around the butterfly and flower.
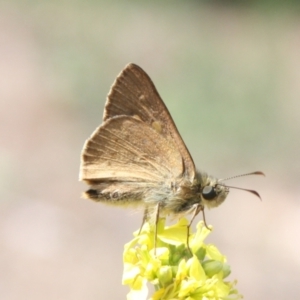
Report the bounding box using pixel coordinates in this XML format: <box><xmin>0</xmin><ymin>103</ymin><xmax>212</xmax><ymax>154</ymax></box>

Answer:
<box><xmin>0</xmin><ymin>0</ymin><xmax>300</xmax><ymax>300</ymax></box>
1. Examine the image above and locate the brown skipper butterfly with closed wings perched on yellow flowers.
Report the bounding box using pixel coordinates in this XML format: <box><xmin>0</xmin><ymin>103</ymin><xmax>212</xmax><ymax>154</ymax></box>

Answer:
<box><xmin>79</xmin><ymin>64</ymin><xmax>263</xmax><ymax>236</ymax></box>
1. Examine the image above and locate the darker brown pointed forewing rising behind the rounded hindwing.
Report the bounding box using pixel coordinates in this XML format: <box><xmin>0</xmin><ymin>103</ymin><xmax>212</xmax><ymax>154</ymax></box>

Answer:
<box><xmin>103</xmin><ymin>64</ymin><xmax>195</xmax><ymax>181</ymax></box>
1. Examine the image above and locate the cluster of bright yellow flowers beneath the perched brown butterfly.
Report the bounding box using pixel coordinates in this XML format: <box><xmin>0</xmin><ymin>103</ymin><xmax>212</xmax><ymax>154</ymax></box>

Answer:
<box><xmin>123</xmin><ymin>218</ymin><xmax>241</xmax><ymax>300</ymax></box>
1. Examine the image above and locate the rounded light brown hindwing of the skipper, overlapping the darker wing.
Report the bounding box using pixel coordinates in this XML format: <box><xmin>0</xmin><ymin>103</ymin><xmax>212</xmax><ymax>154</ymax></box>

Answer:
<box><xmin>80</xmin><ymin>116</ymin><xmax>183</xmax><ymax>184</ymax></box>
